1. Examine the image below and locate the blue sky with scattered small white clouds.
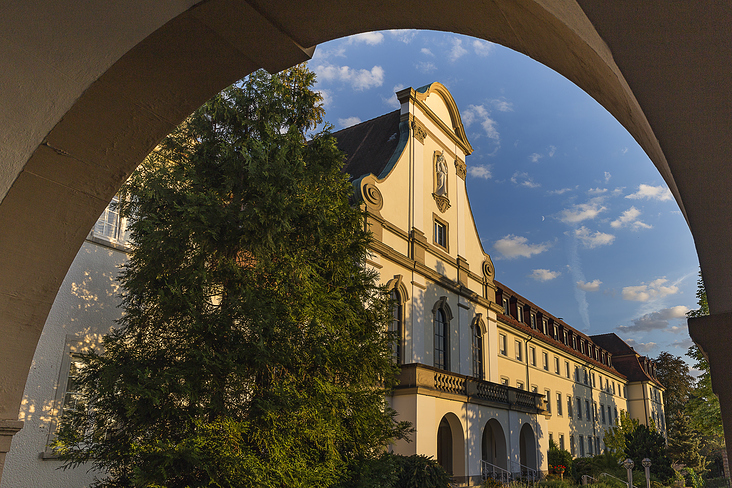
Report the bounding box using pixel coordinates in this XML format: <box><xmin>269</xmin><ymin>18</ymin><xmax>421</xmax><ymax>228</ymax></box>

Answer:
<box><xmin>309</xmin><ymin>30</ymin><xmax>699</xmax><ymax>356</ymax></box>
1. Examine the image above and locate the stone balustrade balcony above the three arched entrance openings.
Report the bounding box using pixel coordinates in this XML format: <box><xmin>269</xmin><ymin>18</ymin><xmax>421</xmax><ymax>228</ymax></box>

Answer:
<box><xmin>395</xmin><ymin>364</ymin><xmax>545</xmax><ymax>414</ymax></box>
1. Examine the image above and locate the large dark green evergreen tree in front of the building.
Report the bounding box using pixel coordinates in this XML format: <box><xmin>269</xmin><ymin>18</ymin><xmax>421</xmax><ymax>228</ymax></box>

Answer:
<box><xmin>56</xmin><ymin>66</ymin><xmax>407</xmax><ymax>488</ymax></box>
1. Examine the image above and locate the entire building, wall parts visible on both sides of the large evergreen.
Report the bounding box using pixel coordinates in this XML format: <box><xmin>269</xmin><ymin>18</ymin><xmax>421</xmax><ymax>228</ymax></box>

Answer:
<box><xmin>0</xmin><ymin>83</ymin><xmax>665</xmax><ymax>488</ymax></box>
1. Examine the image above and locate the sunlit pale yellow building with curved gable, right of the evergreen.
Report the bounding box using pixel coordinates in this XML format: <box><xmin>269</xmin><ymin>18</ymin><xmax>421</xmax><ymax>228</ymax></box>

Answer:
<box><xmin>335</xmin><ymin>83</ymin><xmax>663</xmax><ymax>485</ymax></box>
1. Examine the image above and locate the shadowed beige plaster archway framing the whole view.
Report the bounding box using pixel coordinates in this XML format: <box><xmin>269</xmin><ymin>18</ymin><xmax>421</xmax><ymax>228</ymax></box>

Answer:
<box><xmin>0</xmin><ymin>0</ymin><xmax>732</xmax><ymax>480</ymax></box>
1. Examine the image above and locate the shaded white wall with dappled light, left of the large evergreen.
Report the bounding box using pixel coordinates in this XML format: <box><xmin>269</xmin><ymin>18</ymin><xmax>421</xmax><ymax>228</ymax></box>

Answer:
<box><xmin>0</xmin><ymin>202</ymin><xmax>126</xmax><ymax>488</ymax></box>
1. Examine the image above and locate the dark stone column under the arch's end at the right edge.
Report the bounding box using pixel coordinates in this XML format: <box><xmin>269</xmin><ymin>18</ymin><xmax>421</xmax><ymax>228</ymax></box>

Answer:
<box><xmin>689</xmin><ymin>312</ymin><xmax>732</xmax><ymax>470</ymax></box>
